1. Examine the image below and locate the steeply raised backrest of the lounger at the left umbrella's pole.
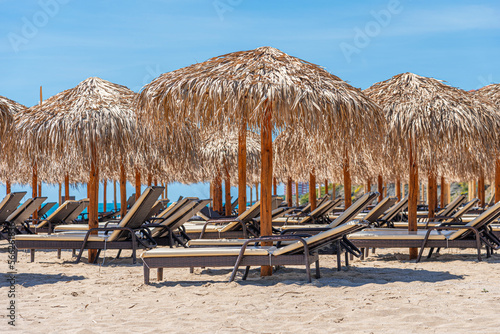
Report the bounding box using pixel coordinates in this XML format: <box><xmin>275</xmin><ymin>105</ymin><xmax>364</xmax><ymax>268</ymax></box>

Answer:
<box><xmin>108</xmin><ymin>186</ymin><xmax>165</xmax><ymax>241</ymax></box>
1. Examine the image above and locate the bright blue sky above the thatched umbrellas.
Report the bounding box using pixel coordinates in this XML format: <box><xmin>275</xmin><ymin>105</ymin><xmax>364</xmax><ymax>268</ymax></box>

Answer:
<box><xmin>0</xmin><ymin>0</ymin><xmax>500</xmax><ymax>204</ymax></box>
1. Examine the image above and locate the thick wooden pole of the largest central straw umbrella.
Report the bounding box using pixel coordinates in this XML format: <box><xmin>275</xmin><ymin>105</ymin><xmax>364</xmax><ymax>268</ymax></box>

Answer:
<box><xmin>260</xmin><ymin>101</ymin><xmax>273</xmax><ymax>276</ymax></box>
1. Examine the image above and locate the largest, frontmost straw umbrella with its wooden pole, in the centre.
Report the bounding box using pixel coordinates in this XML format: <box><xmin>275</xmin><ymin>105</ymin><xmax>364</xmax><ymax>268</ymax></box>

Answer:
<box><xmin>139</xmin><ymin>47</ymin><xmax>384</xmax><ymax>275</ymax></box>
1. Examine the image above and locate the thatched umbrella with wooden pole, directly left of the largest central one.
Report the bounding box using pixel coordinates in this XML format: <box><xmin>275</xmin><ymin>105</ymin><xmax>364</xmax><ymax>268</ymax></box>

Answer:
<box><xmin>14</xmin><ymin>78</ymin><xmax>137</xmax><ymax>260</ymax></box>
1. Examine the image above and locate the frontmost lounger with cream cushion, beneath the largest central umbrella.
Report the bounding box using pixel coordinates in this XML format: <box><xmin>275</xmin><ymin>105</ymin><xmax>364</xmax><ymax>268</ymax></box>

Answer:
<box><xmin>141</xmin><ymin>222</ymin><xmax>365</xmax><ymax>284</ymax></box>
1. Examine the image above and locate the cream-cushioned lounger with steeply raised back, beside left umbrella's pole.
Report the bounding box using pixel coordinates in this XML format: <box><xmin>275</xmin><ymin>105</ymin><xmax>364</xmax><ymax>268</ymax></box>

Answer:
<box><xmin>15</xmin><ymin>187</ymin><xmax>164</xmax><ymax>263</ymax></box>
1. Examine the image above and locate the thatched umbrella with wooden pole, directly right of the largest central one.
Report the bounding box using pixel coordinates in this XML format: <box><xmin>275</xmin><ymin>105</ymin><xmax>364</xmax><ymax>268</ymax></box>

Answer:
<box><xmin>365</xmin><ymin>73</ymin><xmax>500</xmax><ymax>257</ymax></box>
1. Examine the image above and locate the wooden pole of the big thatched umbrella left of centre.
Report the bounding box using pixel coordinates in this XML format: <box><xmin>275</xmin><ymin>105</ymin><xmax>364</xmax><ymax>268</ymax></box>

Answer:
<box><xmin>87</xmin><ymin>144</ymin><xmax>99</xmax><ymax>263</ymax></box>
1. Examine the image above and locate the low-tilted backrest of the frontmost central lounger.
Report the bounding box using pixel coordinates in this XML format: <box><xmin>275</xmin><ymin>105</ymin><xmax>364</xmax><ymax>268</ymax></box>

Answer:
<box><xmin>272</xmin><ymin>222</ymin><xmax>366</xmax><ymax>256</ymax></box>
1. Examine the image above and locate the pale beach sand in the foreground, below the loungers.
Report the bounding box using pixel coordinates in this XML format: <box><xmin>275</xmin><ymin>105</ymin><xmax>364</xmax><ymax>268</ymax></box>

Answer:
<box><xmin>0</xmin><ymin>241</ymin><xmax>500</xmax><ymax>334</ymax></box>
